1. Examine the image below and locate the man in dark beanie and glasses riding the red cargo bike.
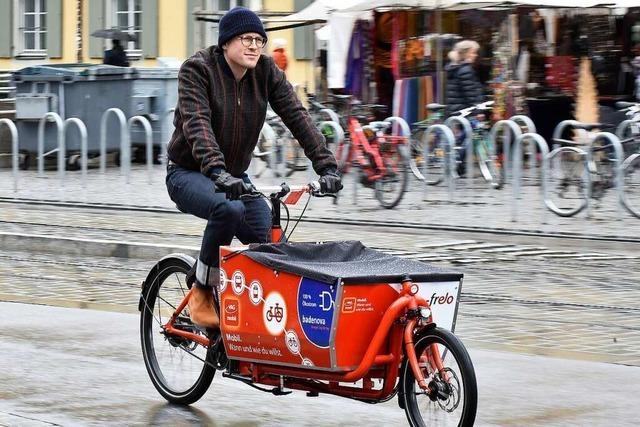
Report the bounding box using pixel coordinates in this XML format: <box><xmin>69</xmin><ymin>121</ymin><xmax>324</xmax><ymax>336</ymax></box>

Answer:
<box><xmin>166</xmin><ymin>7</ymin><xmax>342</xmax><ymax>328</ymax></box>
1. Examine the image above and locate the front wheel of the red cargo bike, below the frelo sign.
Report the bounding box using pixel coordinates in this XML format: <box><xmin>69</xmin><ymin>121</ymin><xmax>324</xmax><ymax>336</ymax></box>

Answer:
<box><xmin>399</xmin><ymin>328</ymin><xmax>478</xmax><ymax>427</ymax></box>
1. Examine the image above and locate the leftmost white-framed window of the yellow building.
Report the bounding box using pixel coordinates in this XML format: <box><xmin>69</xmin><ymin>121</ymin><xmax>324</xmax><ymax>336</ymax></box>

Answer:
<box><xmin>16</xmin><ymin>0</ymin><xmax>47</xmax><ymax>56</ymax></box>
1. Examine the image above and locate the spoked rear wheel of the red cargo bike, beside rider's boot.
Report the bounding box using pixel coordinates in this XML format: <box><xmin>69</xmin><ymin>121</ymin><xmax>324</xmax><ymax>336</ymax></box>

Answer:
<box><xmin>140</xmin><ymin>257</ymin><xmax>216</xmax><ymax>405</ymax></box>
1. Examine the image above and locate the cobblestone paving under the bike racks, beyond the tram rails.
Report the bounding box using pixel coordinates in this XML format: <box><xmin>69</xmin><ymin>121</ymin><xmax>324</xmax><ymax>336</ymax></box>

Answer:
<box><xmin>0</xmin><ymin>165</ymin><xmax>640</xmax><ymax>238</ymax></box>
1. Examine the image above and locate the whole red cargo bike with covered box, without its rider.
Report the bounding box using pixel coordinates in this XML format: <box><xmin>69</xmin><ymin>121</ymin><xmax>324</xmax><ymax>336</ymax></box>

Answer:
<box><xmin>139</xmin><ymin>183</ymin><xmax>477</xmax><ymax>426</ymax></box>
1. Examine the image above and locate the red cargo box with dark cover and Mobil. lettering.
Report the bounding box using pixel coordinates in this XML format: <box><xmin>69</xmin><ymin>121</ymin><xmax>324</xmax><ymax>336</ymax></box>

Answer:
<box><xmin>220</xmin><ymin>242</ymin><xmax>462</xmax><ymax>371</ymax></box>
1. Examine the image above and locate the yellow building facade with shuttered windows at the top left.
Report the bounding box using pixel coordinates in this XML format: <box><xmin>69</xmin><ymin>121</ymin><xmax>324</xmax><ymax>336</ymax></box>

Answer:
<box><xmin>0</xmin><ymin>0</ymin><xmax>314</xmax><ymax>88</ymax></box>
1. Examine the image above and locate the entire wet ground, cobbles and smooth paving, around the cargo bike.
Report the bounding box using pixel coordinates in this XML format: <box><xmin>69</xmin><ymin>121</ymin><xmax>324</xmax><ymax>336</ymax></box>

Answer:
<box><xmin>0</xmin><ymin>167</ymin><xmax>640</xmax><ymax>426</ymax></box>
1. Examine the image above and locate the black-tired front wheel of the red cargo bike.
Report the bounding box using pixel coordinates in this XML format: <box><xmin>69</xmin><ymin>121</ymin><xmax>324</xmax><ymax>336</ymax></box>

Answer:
<box><xmin>398</xmin><ymin>327</ymin><xmax>478</xmax><ymax>427</ymax></box>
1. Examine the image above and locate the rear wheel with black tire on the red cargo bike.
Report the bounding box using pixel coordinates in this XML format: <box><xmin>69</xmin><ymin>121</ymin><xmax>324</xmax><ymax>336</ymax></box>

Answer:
<box><xmin>140</xmin><ymin>257</ymin><xmax>216</xmax><ymax>405</ymax></box>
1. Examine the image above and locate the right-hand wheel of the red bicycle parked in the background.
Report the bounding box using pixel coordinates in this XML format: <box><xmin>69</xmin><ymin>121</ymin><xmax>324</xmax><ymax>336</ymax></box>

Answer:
<box><xmin>374</xmin><ymin>142</ymin><xmax>409</xmax><ymax>209</ymax></box>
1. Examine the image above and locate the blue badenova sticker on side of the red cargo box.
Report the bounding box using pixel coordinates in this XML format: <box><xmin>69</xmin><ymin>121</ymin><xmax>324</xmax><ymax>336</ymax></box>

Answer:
<box><xmin>298</xmin><ymin>277</ymin><xmax>336</xmax><ymax>348</ymax></box>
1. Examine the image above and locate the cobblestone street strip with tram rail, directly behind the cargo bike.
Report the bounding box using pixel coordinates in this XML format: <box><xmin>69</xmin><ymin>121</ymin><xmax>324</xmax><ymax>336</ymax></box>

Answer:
<box><xmin>0</xmin><ymin>200</ymin><xmax>640</xmax><ymax>366</ymax></box>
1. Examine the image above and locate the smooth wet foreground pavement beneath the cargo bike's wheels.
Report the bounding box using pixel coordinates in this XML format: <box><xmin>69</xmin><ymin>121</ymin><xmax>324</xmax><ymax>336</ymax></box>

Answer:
<box><xmin>0</xmin><ymin>303</ymin><xmax>640</xmax><ymax>426</ymax></box>
